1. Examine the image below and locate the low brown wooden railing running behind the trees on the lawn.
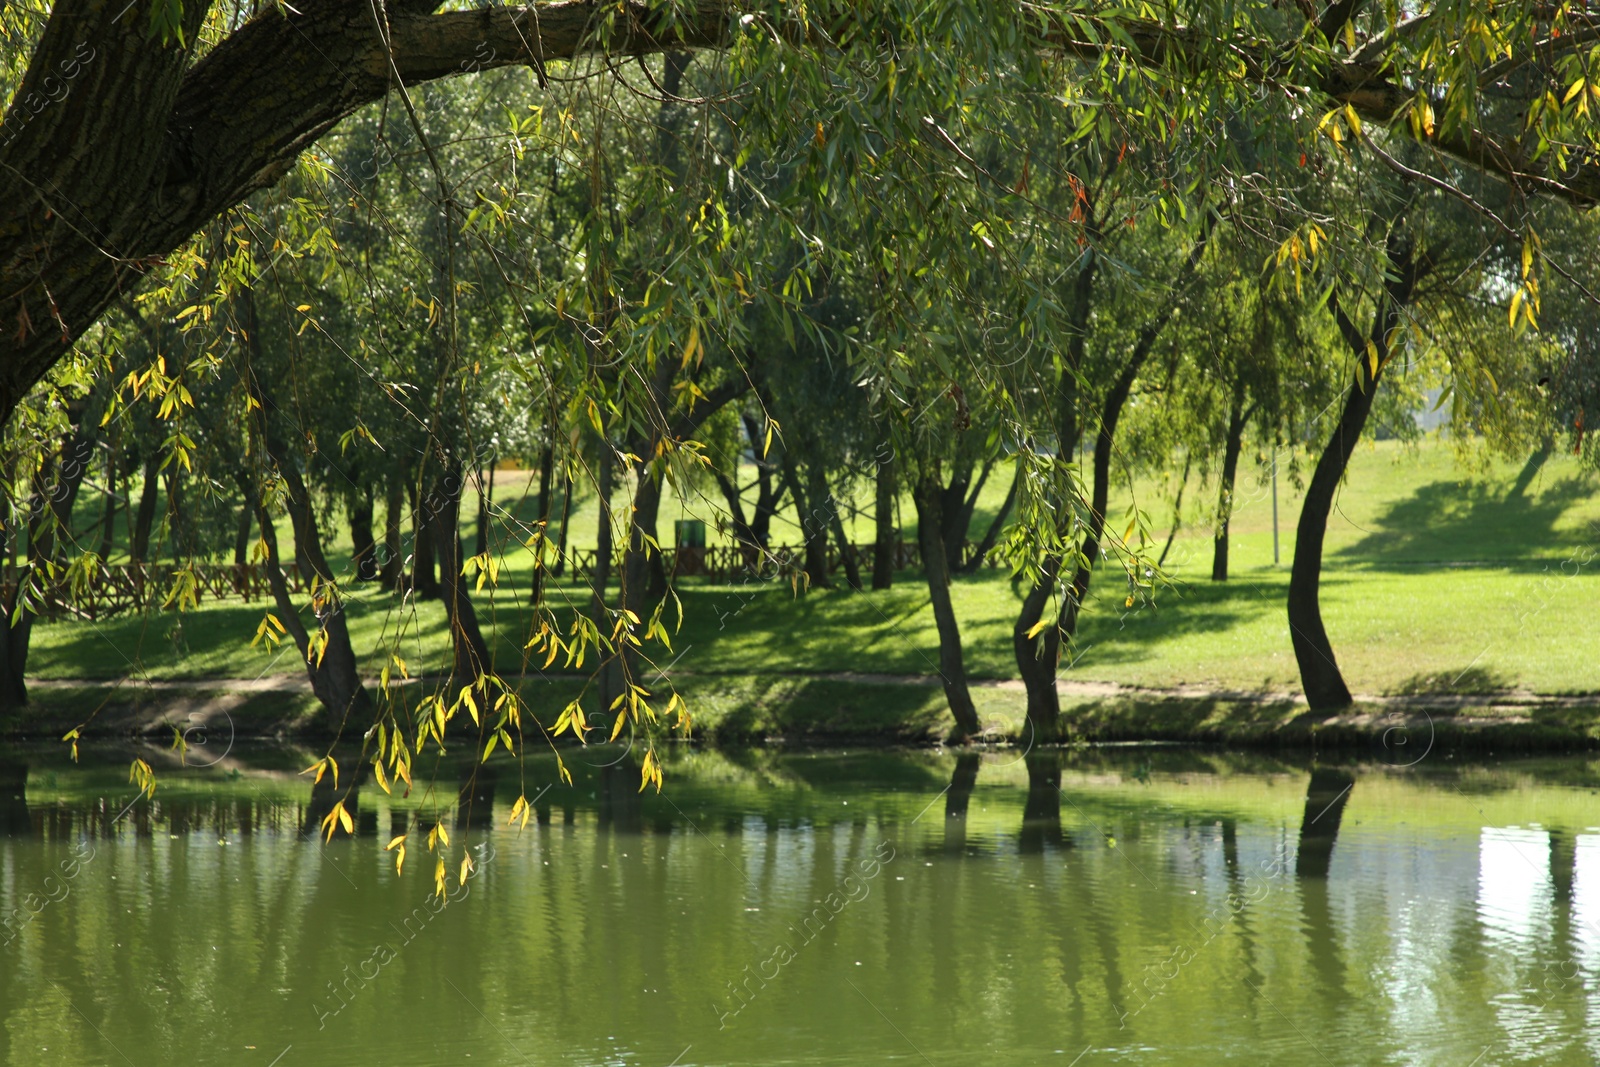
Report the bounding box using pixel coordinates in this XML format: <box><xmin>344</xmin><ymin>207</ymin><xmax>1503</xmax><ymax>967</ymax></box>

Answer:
<box><xmin>0</xmin><ymin>541</ymin><xmax>1002</xmax><ymax>619</ymax></box>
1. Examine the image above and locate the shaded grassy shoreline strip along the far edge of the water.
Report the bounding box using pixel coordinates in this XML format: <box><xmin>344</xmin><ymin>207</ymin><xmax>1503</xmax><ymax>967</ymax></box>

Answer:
<box><xmin>0</xmin><ymin>672</ymin><xmax>1600</xmax><ymax>758</ymax></box>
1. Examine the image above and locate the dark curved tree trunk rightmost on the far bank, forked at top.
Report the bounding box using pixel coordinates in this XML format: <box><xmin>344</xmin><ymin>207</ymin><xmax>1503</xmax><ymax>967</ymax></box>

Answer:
<box><xmin>1288</xmin><ymin>231</ymin><xmax>1418</xmax><ymax>712</ymax></box>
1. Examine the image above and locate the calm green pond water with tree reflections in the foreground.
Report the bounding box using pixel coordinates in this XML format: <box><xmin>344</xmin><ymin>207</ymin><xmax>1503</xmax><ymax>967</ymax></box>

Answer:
<box><xmin>0</xmin><ymin>749</ymin><xmax>1600</xmax><ymax>1067</ymax></box>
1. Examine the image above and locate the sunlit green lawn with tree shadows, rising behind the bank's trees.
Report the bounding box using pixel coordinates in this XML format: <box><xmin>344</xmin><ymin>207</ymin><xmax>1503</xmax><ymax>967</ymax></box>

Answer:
<box><xmin>21</xmin><ymin>442</ymin><xmax>1600</xmax><ymax>703</ymax></box>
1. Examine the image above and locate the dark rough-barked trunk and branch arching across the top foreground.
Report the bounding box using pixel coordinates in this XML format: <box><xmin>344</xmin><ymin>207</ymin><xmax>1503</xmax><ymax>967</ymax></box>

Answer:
<box><xmin>0</xmin><ymin>0</ymin><xmax>1600</xmax><ymax>421</ymax></box>
